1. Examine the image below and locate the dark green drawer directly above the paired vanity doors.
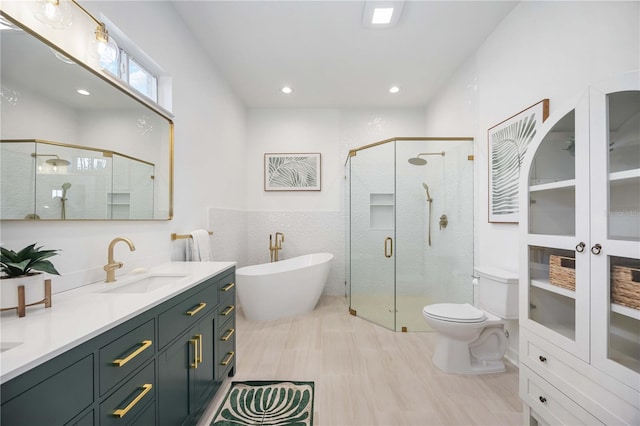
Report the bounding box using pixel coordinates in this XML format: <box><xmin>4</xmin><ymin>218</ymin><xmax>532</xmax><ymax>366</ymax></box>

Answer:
<box><xmin>158</xmin><ymin>282</ymin><xmax>218</xmax><ymax>348</ymax></box>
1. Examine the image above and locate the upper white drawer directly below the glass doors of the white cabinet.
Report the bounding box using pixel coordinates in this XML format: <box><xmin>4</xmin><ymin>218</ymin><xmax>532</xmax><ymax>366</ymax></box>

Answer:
<box><xmin>520</xmin><ymin>329</ymin><xmax>640</xmax><ymax>424</ymax></box>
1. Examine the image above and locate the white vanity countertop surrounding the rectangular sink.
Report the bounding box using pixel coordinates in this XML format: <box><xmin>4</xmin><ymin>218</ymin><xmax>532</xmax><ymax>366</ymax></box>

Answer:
<box><xmin>0</xmin><ymin>262</ymin><xmax>236</xmax><ymax>383</ymax></box>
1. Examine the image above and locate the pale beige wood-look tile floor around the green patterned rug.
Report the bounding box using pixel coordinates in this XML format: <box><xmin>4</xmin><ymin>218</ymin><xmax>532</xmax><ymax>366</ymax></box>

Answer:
<box><xmin>198</xmin><ymin>296</ymin><xmax>522</xmax><ymax>426</ymax></box>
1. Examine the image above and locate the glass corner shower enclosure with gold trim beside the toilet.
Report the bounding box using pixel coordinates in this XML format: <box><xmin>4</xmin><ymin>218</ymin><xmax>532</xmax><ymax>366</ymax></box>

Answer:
<box><xmin>345</xmin><ymin>138</ymin><xmax>474</xmax><ymax>331</ymax></box>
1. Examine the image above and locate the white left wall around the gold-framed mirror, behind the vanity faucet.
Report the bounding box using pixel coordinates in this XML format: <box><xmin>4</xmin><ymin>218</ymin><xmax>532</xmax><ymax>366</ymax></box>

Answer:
<box><xmin>0</xmin><ymin>1</ymin><xmax>247</xmax><ymax>291</ymax></box>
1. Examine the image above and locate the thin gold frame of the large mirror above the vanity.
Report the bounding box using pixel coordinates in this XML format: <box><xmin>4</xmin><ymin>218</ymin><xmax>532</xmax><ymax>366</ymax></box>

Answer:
<box><xmin>0</xmin><ymin>9</ymin><xmax>175</xmax><ymax>222</ymax></box>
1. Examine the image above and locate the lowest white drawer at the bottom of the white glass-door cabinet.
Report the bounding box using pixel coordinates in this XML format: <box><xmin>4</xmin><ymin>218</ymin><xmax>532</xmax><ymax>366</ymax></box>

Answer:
<box><xmin>520</xmin><ymin>365</ymin><xmax>603</xmax><ymax>425</ymax></box>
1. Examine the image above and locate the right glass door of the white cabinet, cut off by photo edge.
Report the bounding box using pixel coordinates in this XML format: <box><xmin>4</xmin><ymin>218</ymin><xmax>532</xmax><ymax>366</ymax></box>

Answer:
<box><xmin>589</xmin><ymin>84</ymin><xmax>640</xmax><ymax>389</ymax></box>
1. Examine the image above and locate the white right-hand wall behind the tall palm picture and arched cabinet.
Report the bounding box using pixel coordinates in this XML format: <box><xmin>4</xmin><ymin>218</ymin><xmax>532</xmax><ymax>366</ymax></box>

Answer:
<box><xmin>425</xmin><ymin>1</ymin><xmax>640</xmax><ymax>362</ymax></box>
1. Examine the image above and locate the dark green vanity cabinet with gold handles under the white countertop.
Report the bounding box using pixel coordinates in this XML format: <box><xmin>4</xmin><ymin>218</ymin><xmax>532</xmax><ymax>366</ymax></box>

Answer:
<box><xmin>0</xmin><ymin>269</ymin><xmax>235</xmax><ymax>426</ymax></box>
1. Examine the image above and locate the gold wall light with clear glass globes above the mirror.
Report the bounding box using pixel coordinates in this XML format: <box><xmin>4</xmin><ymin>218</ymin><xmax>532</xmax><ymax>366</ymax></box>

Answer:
<box><xmin>33</xmin><ymin>0</ymin><xmax>120</xmax><ymax>68</ymax></box>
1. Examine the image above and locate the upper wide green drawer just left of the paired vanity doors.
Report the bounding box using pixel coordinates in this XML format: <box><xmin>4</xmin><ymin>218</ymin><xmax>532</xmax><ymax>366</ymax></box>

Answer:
<box><xmin>99</xmin><ymin>320</ymin><xmax>156</xmax><ymax>395</ymax></box>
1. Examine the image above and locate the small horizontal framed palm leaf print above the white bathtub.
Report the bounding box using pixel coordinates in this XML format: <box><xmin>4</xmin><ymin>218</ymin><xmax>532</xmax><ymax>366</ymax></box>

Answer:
<box><xmin>264</xmin><ymin>152</ymin><xmax>322</xmax><ymax>191</ymax></box>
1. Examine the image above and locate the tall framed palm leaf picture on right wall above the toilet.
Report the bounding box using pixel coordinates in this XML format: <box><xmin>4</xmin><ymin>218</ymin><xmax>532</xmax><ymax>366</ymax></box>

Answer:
<box><xmin>487</xmin><ymin>99</ymin><xmax>549</xmax><ymax>223</ymax></box>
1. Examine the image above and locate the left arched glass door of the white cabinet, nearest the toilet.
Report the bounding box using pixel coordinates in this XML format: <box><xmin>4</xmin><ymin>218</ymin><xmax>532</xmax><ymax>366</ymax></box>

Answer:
<box><xmin>523</xmin><ymin>93</ymin><xmax>589</xmax><ymax>360</ymax></box>
